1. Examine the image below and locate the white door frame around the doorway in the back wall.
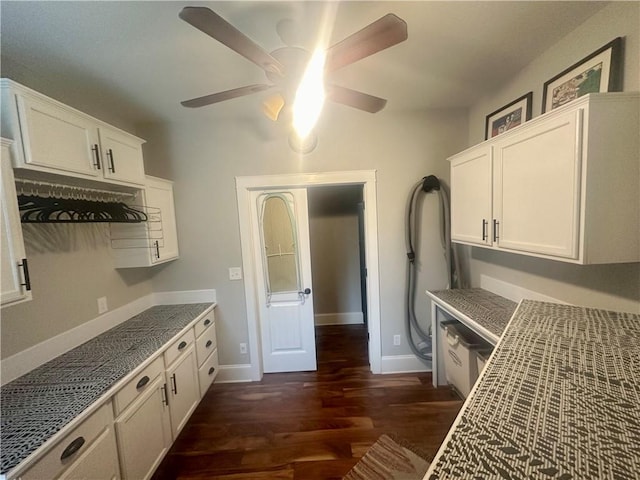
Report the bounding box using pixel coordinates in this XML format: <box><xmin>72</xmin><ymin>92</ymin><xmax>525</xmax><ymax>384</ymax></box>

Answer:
<box><xmin>236</xmin><ymin>170</ymin><xmax>382</xmax><ymax>381</ymax></box>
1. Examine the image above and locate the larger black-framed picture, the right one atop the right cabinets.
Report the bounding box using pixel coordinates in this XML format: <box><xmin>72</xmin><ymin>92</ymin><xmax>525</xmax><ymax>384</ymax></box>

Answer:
<box><xmin>542</xmin><ymin>37</ymin><xmax>622</xmax><ymax>113</ymax></box>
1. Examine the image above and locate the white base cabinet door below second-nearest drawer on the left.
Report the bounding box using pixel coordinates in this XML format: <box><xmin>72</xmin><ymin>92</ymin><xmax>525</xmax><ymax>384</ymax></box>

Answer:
<box><xmin>116</xmin><ymin>375</ymin><xmax>171</xmax><ymax>480</ymax></box>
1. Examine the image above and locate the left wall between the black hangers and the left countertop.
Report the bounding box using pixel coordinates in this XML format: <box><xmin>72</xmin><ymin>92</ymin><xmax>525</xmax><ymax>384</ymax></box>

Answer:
<box><xmin>1</xmin><ymin>224</ymin><xmax>152</xmax><ymax>359</ymax></box>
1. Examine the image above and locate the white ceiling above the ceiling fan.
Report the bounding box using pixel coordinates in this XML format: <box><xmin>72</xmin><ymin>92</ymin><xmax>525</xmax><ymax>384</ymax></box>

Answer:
<box><xmin>0</xmin><ymin>0</ymin><xmax>606</xmax><ymax>122</ymax></box>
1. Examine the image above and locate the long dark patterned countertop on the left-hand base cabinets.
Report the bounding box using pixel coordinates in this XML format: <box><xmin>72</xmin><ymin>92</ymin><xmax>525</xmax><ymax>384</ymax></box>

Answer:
<box><xmin>0</xmin><ymin>303</ymin><xmax>215</xmax><ymax>474</ymax></box>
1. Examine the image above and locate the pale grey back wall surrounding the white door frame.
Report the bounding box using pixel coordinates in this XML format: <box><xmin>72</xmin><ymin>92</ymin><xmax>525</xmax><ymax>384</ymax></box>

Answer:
<box><xmin>140</xmin><ymin>105</ymin><xmax>468</xmax><ymax>364</ymax></box>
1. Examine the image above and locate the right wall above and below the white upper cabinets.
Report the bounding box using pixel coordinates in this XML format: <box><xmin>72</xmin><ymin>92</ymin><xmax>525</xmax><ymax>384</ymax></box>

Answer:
<box><xmin>465</xmin><ymin>2</ymin><xmax>640</xmax><ymax>313</ymax></box>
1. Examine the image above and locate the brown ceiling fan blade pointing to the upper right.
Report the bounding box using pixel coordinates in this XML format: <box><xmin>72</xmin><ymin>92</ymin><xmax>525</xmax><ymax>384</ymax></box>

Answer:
<box><xmin>326</xmin><ymin>13</ymin><xmax>408</xmax><ymax>72</ymax></box>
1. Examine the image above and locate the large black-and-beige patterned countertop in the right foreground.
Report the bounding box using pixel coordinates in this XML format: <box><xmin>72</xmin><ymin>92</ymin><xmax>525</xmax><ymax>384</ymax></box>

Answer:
<box><xmin>424</xmin><ymin>300</ymin><xmax>640</xmax><ymax>480</ymax></box>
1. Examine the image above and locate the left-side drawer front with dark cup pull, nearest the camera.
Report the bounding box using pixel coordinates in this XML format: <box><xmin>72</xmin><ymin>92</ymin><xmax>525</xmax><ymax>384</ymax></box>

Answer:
<box><xmin>19</xmin><ymin>402</ymin><xmax>113</xmax><ymax>480</ymax></box>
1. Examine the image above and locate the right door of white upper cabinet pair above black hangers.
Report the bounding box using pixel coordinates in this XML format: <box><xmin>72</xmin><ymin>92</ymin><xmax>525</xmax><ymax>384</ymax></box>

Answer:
<box><xmin>99</xmin><ymin>126</ymin><xmax>144</xmax><ymax>185</ymax></box>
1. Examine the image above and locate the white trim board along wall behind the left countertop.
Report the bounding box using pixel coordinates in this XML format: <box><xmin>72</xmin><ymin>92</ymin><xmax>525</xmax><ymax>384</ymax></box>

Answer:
<box><xmin>0</xmin><ymin>290</ymin><xmax>216</xmax><ymax>385</ymax></box>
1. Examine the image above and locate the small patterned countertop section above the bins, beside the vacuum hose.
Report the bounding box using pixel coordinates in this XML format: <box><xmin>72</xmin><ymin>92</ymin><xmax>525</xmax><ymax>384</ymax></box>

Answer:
<box><xmin>427</xmin><ymin>288</ymin><xmax>518</xmax><ymax>343</ymax></box>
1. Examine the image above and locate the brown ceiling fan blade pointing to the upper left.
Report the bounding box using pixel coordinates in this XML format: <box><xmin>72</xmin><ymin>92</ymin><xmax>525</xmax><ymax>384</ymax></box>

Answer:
<box><xmin>179</xmin><ymin>7</ymin><xmax>284</xmax><ymax>76</ymax></box>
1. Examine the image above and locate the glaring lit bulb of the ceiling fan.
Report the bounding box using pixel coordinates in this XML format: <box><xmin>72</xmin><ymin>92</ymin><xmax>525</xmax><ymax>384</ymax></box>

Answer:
<box><xmin>293</xmin><ymin>49</ymin><xmax>326</xmax><ymax>139</ymax></box>
